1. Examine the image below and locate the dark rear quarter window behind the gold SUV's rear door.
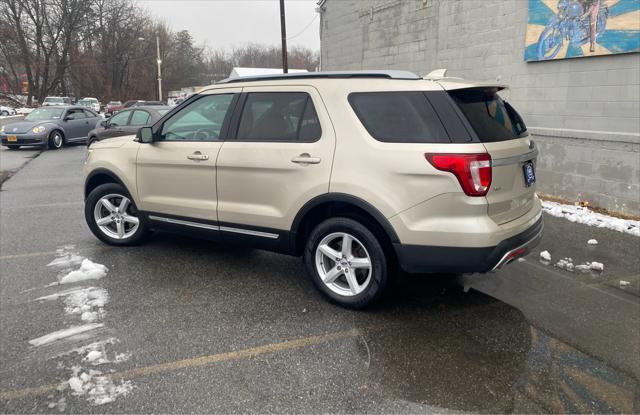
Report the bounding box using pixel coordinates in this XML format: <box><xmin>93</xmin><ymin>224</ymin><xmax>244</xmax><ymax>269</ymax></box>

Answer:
<box><xmin>349</xmin><ymin>91</ymin><xmax>450</xmax><ymax>143</ymax></box>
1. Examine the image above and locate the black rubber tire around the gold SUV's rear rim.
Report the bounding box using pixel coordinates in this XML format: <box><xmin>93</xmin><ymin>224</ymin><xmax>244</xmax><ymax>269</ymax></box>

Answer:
<box><xmin>304</xmin><ymin>217</ymin><xmax>389</xmax><ymax>309</ymax></box>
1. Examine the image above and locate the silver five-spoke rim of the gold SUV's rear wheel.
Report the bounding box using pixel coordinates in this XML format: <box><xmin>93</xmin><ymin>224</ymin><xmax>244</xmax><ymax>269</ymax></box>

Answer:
<box><xmin>316</xmin><ymin>232</ymin><xmax>372</xmax><ymax>297</ymax></box>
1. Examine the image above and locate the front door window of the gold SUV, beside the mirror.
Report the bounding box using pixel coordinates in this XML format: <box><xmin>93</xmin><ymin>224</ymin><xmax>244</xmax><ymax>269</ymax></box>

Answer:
<box><xmin>160</xmin><ymin>94</ymin><xmax>234</xmax><ymax>141</ymax></box>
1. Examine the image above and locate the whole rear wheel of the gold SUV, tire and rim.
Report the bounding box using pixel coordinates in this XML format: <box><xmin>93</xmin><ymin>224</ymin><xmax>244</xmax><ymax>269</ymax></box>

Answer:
<box><xmin>304</xmin><ymin>218</ymin><xmax>389</xmax><ymax>309</ymax></box>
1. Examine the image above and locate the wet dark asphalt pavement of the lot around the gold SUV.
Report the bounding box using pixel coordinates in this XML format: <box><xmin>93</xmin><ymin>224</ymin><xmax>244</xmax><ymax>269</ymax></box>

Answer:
<box><xmin>0</xmin><ymin>146</ymin><xmax>640</xmax><ymax>413</ymax></box>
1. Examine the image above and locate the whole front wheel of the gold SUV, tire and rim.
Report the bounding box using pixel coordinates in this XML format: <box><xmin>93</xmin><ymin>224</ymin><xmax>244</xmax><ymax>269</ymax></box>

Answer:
<box><xmin>84</xmin><ymin>183</ymin><xmax>148</xmax><ymax>246</ymax></box>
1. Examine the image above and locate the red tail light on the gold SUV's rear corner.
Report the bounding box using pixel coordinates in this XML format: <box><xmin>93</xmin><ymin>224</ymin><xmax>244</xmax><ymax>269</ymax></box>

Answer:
<box><xmin>424</xmin><ymin>153</ymin><xmax>491</xmax><ymax>196</ymax></box>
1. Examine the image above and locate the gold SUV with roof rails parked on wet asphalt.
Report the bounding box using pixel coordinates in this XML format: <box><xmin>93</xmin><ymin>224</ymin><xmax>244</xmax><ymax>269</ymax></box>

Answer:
<box><xmin>84</xmin><ymin>71</ymin><xmax>543</xmax><ymax>308</ymax></box>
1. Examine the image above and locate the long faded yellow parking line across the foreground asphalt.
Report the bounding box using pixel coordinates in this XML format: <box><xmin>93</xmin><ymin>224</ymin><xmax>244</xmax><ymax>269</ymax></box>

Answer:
<box><xmin>0</xmin><ymin>326</ymin><xmax>370</xmax><ymax>401</ymax></box>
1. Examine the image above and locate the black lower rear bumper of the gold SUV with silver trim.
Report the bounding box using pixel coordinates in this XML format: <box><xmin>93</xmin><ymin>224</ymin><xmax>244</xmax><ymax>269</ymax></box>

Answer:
<box><xmin>394</xmin><ymin>216</ymin><xmax>544</xmax><ymax>273</ymax></box>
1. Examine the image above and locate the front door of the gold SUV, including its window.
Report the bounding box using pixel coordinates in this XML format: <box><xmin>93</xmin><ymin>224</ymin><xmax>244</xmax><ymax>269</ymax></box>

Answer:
<box><xmin>137</xmin><ymin>88</ymin><xmax>241</xmax><ymax>223</ymax></box>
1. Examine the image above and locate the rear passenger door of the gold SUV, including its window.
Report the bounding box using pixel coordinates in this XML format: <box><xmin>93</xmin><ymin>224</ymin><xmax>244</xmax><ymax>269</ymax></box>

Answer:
<box><xmin>217</xmin><ymin>86</ymin><xmax>335</xmax><ymax>234</ymax></box>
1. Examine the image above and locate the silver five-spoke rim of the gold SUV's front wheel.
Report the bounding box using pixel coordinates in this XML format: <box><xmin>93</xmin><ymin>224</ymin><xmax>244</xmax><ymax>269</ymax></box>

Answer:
<box><xmin>93</xmin><ymin>193</ymin><xmax>140</xmax><ymax>240</ymax></box>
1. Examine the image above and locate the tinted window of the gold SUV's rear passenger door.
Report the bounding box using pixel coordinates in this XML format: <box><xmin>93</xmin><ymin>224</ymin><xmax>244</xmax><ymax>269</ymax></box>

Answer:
<box><xmin>237</xmin><ymin>92</ymin><xmax>322</xmax><ymax>141</ymax></box>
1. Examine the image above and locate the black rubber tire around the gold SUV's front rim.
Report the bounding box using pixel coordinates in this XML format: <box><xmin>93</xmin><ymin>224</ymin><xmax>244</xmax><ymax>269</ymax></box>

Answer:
<box><xmin>84</xmin><ymin>183</ymin><xmax>149</xmax><ymax>246</ymax></box>
